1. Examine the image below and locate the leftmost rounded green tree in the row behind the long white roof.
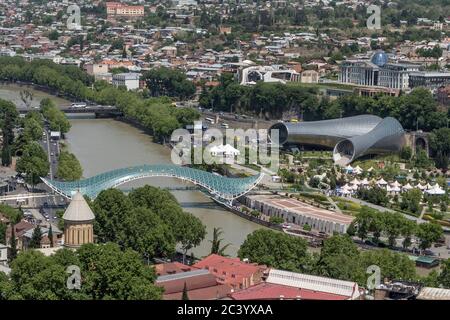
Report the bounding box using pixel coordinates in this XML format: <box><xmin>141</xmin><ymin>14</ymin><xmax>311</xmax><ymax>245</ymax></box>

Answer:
<box><xmin>238</xmin><ymin>229</ymin><xmax>310</xmax><ymax>272</ymax></box>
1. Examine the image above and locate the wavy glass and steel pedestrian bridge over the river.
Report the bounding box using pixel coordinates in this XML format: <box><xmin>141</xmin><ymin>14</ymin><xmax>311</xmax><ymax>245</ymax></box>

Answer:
<box><xmin>41</xmin><ymin>164</ymin><xmax>263</xmax><ymax>201</ymax></box>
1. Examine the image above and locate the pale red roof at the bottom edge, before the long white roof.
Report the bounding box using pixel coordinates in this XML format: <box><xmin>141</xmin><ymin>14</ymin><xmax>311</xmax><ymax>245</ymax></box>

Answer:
<box><xmin>230</xmin><ymin>282</ymin><xmax>349</xmax><ymax>300</ymax></box>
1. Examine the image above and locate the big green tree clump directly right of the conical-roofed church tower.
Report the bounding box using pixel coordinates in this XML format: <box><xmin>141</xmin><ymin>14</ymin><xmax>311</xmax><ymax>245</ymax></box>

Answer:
<box><xmin>92</xmin><ymin>186</ymin><xmax>206</xmax><ymax>258</ymax></box>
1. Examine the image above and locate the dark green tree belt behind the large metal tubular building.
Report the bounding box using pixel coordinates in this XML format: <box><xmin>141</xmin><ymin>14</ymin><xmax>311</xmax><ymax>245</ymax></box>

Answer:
<box><xmin>200</xmin><ymin>75</ymin><xmax>448</xmax><ymax>131</ymax></box>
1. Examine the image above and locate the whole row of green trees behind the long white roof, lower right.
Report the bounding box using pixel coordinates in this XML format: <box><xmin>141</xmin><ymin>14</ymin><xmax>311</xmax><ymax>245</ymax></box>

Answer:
<box><xmin>238</xmin><ymin>229</ymin><xmax>418</xmax><ymax>286</ymax></box>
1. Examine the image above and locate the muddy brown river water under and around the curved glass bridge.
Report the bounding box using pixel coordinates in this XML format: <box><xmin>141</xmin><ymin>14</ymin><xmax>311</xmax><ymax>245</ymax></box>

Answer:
<box><xmin>67</xmin><ymin>119</ymin><xmax>261</xmax><ymax>257</ymax></box>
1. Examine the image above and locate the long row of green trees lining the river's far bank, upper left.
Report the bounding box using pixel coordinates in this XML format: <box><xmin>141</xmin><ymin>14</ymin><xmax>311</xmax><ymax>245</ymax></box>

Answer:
<box><xmin>0</xmin><ymin>57</ymin><xmax>200</xmax><ymax>141</ymax></box>
